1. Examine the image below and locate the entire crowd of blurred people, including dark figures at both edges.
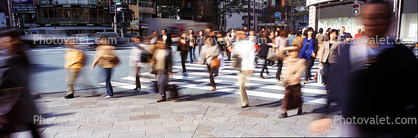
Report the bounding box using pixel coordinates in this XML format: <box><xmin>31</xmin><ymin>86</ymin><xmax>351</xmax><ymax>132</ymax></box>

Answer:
<box><xmin>0</xmin><ymin>1</ymin><xmax>418</xmax><ymax>137</ymax></box>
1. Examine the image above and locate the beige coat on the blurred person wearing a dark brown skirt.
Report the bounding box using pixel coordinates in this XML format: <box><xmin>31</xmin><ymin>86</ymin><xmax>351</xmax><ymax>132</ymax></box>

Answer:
<box><xmin>278</xmin><ymin>50</ymin><xmax>306</xmax><ymax>87</ymax></box>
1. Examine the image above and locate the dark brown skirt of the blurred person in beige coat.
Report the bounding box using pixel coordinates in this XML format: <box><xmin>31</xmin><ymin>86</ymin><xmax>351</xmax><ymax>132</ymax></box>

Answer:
<box><xmin>282</xmin><ymin>84</ymin><xmax>303</xmax><ymax>110</ymax></box>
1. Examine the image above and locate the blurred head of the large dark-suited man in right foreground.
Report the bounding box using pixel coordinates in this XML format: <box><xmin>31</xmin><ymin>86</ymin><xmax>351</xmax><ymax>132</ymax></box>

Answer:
<box><xmin>361</xmin><ymin>4</ymin><xmax>391</xmax><ymax>37</ymax></box>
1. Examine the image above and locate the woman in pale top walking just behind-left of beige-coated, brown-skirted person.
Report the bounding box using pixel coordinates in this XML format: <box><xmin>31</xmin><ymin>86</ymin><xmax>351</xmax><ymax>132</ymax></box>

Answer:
<box><xmin>270</xmin><ymin>30</ymin><xmax>289</xmax><ymax>81</ymax></box>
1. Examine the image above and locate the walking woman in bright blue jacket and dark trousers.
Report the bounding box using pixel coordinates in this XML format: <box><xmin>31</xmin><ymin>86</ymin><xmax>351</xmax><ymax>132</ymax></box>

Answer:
<box><xmin>298</xmin><ymin>27</ymin><xmax>318</xmax><ymax>84</ymax></box>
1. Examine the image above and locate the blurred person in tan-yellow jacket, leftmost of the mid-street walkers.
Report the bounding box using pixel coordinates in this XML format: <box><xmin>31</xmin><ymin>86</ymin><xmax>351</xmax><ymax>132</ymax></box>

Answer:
<box><xmin>64</xmin><ymin>39</ymin><xmax>86</xmax><ymax>99</ymax></box>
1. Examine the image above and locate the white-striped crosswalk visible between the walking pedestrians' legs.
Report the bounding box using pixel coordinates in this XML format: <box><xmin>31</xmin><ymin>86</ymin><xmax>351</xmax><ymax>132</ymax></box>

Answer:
<box><xmin>100</xmin><ymin>53</ymin><xmax>326</xmax><ymax>104</ymax></box>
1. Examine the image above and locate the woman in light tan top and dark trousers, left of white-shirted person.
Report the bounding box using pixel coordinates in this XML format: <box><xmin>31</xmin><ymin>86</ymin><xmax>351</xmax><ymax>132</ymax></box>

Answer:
<box><xmin>199</xmin><ymin>36</ymin><xmax>220</xmax><ymax>91</ymax></box>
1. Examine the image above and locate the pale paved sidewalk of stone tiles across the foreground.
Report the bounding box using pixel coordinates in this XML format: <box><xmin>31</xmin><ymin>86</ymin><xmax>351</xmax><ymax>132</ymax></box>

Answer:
<box><xmin>12</xmin><ymin>95</ymin><xmax>339</xmax><ymax>138</ymax></box>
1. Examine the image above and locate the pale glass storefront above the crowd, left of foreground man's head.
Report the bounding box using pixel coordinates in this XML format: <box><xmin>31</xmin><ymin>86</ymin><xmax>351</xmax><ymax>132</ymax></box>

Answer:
<box><xmin>318</xmin><ymin>17</ymin><xmax>364</xmax><ymax>36</ymax></box>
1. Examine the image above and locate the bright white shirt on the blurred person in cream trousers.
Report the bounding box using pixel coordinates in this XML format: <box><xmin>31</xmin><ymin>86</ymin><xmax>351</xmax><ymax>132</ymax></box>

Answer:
<box><xmin>232</xmin><ymin>40</ymin><xmax>255</xmax><ymax>71</ymax></box>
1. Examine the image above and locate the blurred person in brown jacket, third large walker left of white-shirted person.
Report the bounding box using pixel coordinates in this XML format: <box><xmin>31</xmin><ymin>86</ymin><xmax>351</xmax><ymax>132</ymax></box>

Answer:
<box><xmin>150</xmin><ymin>39</ymin><xmax>174</xmax><ymax>102</ymax></box>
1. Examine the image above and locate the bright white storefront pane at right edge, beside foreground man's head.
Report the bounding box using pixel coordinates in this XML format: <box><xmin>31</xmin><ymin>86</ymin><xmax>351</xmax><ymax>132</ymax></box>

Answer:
<box><xmin>399</xmin><ymin>13</ymin><xmax>418</xmax><ymax>42</ymax></box>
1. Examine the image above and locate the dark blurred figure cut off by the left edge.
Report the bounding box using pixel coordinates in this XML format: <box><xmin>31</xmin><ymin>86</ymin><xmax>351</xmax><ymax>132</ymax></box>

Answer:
<box><xmin>0</xmin><ymin>29</ymin><xmax>40</xmax><ymax>138</ymax></box>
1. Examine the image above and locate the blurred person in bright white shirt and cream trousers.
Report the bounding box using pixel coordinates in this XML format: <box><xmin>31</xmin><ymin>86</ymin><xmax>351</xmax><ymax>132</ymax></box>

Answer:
<box><xmin>232</xmin><ymin>31</ymin><xmax>255</xmax><ymax>108</ymax></box>
